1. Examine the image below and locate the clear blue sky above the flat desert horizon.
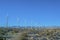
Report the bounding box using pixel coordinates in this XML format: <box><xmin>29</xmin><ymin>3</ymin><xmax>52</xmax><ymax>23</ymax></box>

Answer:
<box><xmin>0</xmin><ymin>0</ymin><xmax>60</xmax><ymax>26</ymax></box>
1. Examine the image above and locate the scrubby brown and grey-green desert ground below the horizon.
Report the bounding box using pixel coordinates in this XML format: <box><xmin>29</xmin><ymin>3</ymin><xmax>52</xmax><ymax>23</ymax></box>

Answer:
<box><xmin>0</xmin><ymin>28</ymin><xmax>60</xmax><ymax>40</ymax></box>
